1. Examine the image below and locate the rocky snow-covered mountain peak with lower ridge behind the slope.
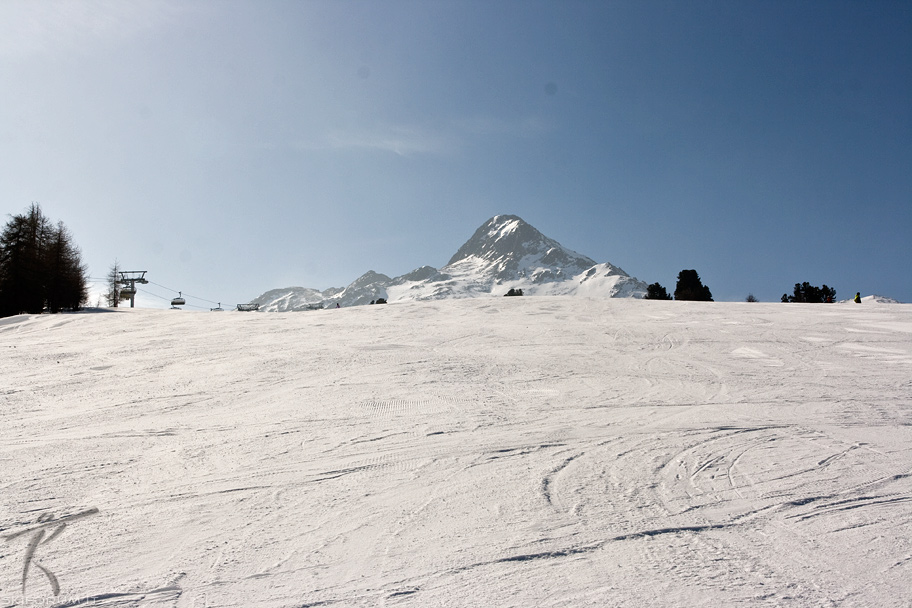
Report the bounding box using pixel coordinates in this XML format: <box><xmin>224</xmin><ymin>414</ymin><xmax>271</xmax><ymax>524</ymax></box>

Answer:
<box><xmin>251</xmin><ymin>215</ymin><xmax>647</xmax><ymax>312</ymax></box>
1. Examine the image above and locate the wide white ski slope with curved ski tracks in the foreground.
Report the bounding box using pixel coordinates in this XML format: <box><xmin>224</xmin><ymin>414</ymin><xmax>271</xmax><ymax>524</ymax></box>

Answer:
<box><xmin>0</xmin><ymin>297</ymin><xmax>912</xmax><ymax>608</ymax></box>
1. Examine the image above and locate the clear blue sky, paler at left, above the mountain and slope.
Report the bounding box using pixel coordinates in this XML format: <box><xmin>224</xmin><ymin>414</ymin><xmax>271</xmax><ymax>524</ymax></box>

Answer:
<box><xmin>0</xmin><ymin>0</ymin><xmax>912</xmax><ymax>307</ymax></box>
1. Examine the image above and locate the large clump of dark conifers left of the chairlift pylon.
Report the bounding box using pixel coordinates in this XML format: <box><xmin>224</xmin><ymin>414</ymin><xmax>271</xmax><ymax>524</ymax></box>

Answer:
<box><xmin>0</xmin><ymin>203</ymin><xmax>89</xmax><ymax>317</ymax></box>
